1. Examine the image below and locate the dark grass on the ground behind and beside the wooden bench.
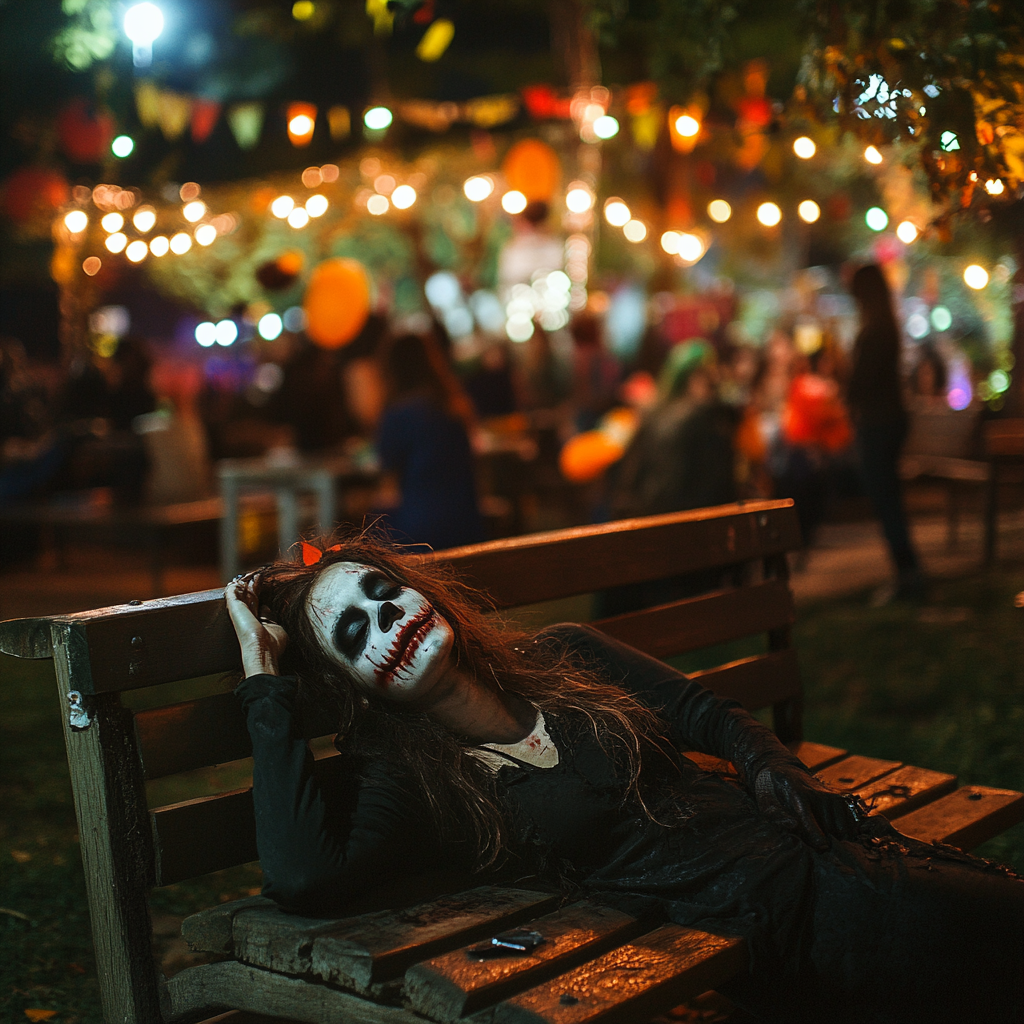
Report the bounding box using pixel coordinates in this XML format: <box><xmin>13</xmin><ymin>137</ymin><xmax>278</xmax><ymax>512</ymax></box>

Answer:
<box><xmin>0</xmin><ymin>570</ymin><xmax>1024</xmax><ymax>1024</ymax></box>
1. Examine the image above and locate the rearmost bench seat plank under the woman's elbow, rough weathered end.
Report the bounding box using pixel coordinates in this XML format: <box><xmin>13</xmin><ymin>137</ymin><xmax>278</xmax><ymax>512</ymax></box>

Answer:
<box><xmin>219</xmin><ymin>886</ymin><xmax>557</xmax><ymax>994</ymax></box>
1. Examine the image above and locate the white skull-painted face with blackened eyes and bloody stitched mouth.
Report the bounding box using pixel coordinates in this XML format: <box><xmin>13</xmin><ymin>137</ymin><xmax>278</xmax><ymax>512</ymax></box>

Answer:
<box><xmin>308</xmin><ymin>562</ymin><xmax>455</xmax><ymax>700</ymax></box>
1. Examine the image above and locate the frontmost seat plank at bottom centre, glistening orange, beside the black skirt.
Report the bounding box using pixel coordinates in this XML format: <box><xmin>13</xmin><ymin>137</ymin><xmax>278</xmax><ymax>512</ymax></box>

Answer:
<box><xmin>493</xmin><ymin>925</ymin><xmax>746</xmax><ymax>1024</ymax></box>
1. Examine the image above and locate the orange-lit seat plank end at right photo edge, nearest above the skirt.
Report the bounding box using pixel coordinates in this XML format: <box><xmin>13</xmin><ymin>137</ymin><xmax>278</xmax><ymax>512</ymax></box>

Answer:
<box><xmin>895</xmin><ymin>785</ymin><xmax>1024</xmax><ymax>850</ymax></box>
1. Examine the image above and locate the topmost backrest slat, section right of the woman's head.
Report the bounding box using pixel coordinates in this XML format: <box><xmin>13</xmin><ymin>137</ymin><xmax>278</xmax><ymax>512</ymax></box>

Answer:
<box><xmin>436</xmin><ymin>501</ymin><xmax>800</xmax><ymax>608</ymax></box>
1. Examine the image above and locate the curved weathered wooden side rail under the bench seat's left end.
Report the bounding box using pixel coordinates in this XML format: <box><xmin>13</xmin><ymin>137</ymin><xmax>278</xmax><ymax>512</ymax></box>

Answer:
<box><xmin>163</xmin><ymin>961</ymin><xmax>423</xmax><ymax>1024</ymax></box>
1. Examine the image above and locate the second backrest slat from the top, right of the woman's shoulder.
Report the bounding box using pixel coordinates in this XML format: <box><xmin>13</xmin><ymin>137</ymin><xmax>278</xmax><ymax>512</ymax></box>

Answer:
<box><xmin>593</xmin><ymin>580</ymin><xmax>795</xmax><ymax>657</ymax></box>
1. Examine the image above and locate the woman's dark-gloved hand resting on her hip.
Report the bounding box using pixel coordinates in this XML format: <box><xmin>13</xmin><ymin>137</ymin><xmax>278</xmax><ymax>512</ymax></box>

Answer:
<box><xmin>754</xmin><ymin>765</ymin><xmax>863</xmax><ymax>850</ymax></box>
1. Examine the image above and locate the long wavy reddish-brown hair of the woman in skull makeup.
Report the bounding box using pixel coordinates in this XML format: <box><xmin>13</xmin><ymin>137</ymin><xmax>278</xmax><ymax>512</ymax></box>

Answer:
<box><xmin>259</xmin><ymin>532</ymin><xmax>668</xmax><ymax>868</ymax></box>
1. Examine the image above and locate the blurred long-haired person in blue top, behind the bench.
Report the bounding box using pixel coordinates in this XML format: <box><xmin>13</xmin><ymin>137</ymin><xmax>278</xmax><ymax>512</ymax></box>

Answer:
<box><xmin>376</xmin><ymin>334</ymin><xmax>484</xmax><ymax>550</ymax></box>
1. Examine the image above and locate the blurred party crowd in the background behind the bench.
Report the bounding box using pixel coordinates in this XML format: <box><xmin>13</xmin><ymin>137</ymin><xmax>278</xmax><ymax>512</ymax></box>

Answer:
<box><xmin>0</xmin><ymin>266</ymin><xmax>970</xmax><ymax>590</ymax></box>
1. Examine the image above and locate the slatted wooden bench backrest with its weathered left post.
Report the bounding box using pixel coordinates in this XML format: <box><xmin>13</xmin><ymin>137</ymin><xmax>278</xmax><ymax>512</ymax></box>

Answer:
<box><xmin>0</xmin><ymin>501</ymin><xmax>801</xmax><ymax>1022</ymax></box>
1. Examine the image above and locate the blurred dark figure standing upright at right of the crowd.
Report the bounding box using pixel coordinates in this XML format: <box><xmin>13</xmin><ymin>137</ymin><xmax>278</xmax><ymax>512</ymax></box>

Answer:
<box><xmin>846</xmin><ymin>263</ymin><xmax>925</xmax><ymax>602</ymax></box>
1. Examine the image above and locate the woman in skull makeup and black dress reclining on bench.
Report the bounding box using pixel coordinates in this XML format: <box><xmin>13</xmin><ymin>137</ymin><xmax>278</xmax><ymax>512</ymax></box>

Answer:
<box><xmin>227</xmin><ymin>538</ymin><xmax>1024</xmax><ymax>1024</ymax></box>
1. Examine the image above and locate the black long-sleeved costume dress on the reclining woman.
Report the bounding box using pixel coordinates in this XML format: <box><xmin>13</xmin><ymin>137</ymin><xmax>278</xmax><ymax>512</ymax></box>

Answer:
<box><xmin>238</xmin><ymin>626</ymin><xmax>1024</xmax><ymax>1024</ymax></box>
